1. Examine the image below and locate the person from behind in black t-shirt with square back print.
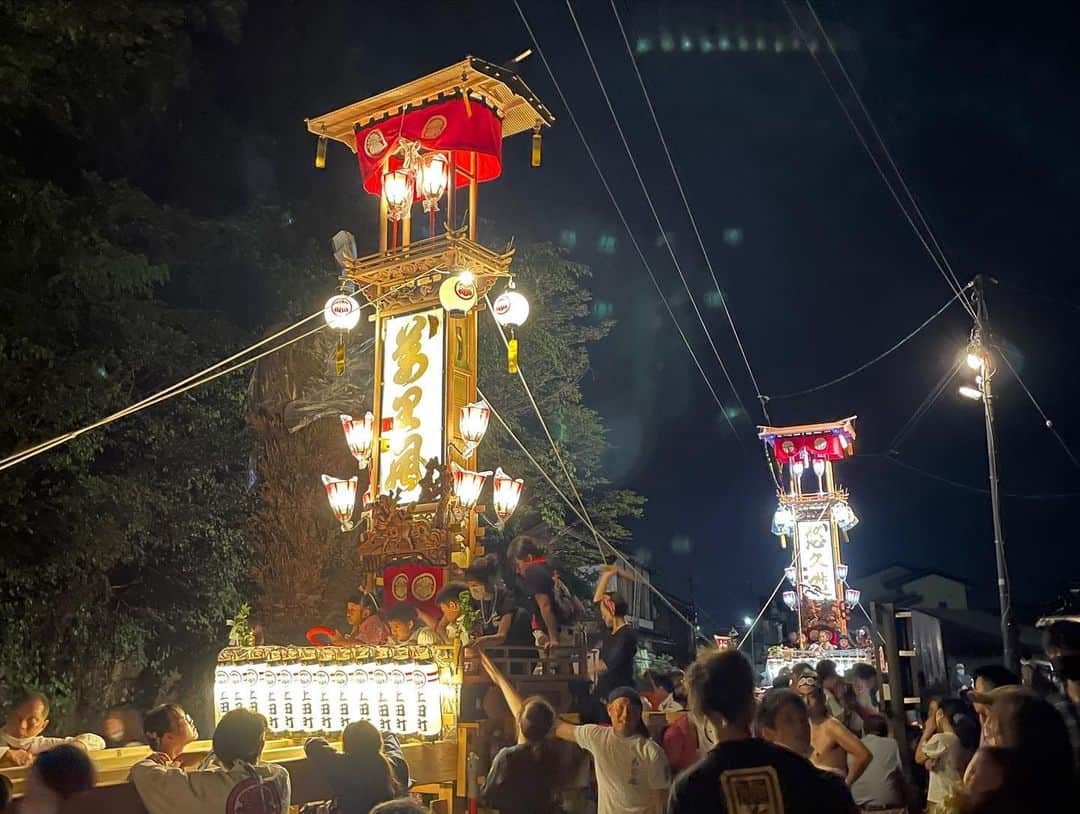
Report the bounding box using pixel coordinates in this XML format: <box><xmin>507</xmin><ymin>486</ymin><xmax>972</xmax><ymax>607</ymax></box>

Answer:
<box><xmin>667</xmin><ymin>650</ymin><xmax>858</xmax><ymax>814</ymax></box>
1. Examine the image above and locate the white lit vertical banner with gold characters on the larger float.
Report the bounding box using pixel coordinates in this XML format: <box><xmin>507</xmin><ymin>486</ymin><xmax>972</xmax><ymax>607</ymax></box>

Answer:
<box><xmin>379</xmin><ymin>308</ymin><xmax>446</xmax><ymax>503</ymax></box>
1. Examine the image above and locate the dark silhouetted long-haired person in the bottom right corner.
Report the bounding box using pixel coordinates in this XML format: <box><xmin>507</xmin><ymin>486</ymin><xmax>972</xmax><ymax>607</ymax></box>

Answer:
<box><xmin>962</xmin><ymin>684</ymin><xmax>1080</xmax><ymax>814</ymax></box>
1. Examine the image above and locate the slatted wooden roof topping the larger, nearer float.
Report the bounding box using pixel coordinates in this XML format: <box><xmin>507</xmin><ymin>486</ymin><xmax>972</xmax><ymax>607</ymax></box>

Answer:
<box><xmin>306</xmin><ymin>56</ymin><xmax>555</xmax><ymax>152</ymax></box>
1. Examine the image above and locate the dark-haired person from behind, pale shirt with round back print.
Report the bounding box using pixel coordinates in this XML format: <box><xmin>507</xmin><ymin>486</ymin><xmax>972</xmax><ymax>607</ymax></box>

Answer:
<box><xmin>129</xmin><ymin>709</ymin><xmax>292</xmax><ymax>814</ymax></box>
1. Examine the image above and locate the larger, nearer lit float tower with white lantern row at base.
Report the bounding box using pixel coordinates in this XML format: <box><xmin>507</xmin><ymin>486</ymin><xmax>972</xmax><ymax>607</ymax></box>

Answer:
<box><xmin>215</xmin><ymin>57</ymin><xmax>553</xmax><ymax>747</ymax></box>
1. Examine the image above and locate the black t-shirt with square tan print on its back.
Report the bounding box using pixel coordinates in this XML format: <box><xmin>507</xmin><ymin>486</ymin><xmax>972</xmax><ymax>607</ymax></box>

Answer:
<box><xmin>667</xmin><ymin>738</ymin><xmax>859</xmax><ymax>814</ymax></box>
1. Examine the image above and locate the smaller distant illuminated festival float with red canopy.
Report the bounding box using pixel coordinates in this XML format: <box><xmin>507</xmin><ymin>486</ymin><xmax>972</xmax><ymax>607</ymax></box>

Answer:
<box><xmin>758</xmin><ymin>416</ymin><xmax>874</xmax><ymax>680</ymax></box>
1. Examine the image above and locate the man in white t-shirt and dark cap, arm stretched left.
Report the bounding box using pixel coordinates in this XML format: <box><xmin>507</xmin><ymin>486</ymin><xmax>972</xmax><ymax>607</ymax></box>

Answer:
<box><xmin>555</xmin><ymin>687</ymin><xmax>671</xmax><ymax>814</ymax></box>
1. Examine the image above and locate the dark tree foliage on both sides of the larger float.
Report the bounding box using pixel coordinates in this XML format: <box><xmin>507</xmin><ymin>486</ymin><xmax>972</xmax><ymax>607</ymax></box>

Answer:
<box><xmin>0</xmin><ymin>0</ymin><xmax>642</xmax><ymax>728</ymax></box>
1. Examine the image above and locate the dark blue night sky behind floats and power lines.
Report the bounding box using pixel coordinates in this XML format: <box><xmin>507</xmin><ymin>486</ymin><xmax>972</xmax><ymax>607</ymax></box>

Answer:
<box><xmin>162</xmin><ymin>0</ymin><xmax>1080</xmax><ymax>628</ymax></box>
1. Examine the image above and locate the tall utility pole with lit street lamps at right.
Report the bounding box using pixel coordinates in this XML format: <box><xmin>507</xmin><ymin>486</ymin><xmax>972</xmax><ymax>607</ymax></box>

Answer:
<box><xmin>969</xmin><ymin>274</ymin><xmax>1020</xmax><ymax>673</ymax></box>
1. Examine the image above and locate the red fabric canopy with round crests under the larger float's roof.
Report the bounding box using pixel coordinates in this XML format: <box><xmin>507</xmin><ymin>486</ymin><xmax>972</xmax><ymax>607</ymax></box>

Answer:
<box><xmin>356</xmin><ymin>96</ymin><xmax>502</xmax><ymax>195</ymax></box>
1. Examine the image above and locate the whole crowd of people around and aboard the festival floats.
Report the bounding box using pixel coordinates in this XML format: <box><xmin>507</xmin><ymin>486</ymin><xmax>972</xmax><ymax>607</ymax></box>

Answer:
<box><xmin>0</xmin><ymin>539</ymin><xmax>1080</xmax><ymax>814</ymax></box>
